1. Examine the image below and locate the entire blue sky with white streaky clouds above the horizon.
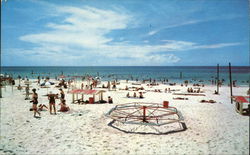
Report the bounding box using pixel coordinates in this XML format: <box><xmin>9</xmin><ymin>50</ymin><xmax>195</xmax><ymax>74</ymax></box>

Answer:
<box><xmin>1</xmin><ymin>0</ymin><xmax>250</xmax><ymax>66</ymax></box>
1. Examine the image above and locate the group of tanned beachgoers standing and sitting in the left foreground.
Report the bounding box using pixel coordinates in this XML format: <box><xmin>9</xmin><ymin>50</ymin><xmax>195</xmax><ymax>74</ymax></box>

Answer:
<box><xmin>30</xmin><ymin>89</ymin><xmax>70</xmax><ymax>117</ymax></box>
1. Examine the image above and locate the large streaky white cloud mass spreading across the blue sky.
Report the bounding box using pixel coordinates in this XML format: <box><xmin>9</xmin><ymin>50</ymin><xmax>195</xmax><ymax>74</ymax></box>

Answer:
<box><xmin>17</xmin><ymin>7</ymin><xmax>238</xmax><ymax>65</ymax></box>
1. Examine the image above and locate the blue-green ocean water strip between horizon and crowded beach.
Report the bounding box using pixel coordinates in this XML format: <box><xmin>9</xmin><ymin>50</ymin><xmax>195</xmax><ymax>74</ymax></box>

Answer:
<box><xmin>1</xmin><ymin>66</ymin><xmax>250</xmax><ymax>85</ymax></box>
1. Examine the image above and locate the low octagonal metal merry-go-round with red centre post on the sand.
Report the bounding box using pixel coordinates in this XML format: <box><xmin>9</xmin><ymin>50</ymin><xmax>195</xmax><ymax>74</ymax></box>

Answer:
<box><xmin>106</xmin><ymin>102</ymin><xmax>187</xmax><ymax>134</ymax></box>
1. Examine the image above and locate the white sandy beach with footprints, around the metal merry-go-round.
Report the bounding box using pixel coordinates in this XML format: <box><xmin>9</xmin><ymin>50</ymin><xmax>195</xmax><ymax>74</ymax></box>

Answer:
<box><xmin>0</xmin><ymin>81</ymin><xmax>249</xmax><ymax>154</ymax></box>
